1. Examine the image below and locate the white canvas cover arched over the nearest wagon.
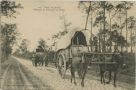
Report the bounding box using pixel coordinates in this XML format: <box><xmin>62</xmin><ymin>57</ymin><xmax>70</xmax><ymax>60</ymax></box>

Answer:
<box><xmin>54</xmin><ymin>29</ymin><xmax>91</xmax><ymax>51</ymax></box>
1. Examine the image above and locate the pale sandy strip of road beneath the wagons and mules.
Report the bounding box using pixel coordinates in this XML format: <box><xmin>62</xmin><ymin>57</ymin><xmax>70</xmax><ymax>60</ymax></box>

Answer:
<box><xmin>9</xmin><ymin>58</ymin><xmax>133</xmax><ymax>90</ymax></box>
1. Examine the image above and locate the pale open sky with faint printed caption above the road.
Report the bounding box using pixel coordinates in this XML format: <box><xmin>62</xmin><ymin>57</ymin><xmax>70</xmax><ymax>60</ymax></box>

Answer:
<box><xmin>4</xmin><ymin>0</ymin><xmax>136</xmax><ymax>50</ymax></box>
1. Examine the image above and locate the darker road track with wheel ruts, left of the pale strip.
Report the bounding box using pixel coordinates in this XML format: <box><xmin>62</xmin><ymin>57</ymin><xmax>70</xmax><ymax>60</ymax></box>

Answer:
<box><xmin>0</xmin><ymin>57</ymin><xmax>52</xmax><ymax>90</ymax></box>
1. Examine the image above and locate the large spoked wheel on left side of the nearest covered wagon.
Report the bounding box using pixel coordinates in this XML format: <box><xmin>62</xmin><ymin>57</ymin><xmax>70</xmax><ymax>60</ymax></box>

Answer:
<box><xmin>58</xmin><ymin>55</ymin><xmax>66</xmax><ymax>78</ymax></box>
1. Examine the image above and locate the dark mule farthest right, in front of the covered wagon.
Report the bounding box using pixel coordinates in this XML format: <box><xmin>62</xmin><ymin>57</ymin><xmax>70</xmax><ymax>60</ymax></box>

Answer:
<box><xmin>99</xmin><ymin>55</ymin><xmax>123</xmax><ymax>87</ymax></box>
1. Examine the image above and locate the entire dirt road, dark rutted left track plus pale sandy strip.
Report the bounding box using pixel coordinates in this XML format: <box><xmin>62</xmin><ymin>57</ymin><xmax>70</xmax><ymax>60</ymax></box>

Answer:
<box><xmin>1</xmin><ymin>57</ymin><xmax>134</xmax><ymax>90</ymax></box>
